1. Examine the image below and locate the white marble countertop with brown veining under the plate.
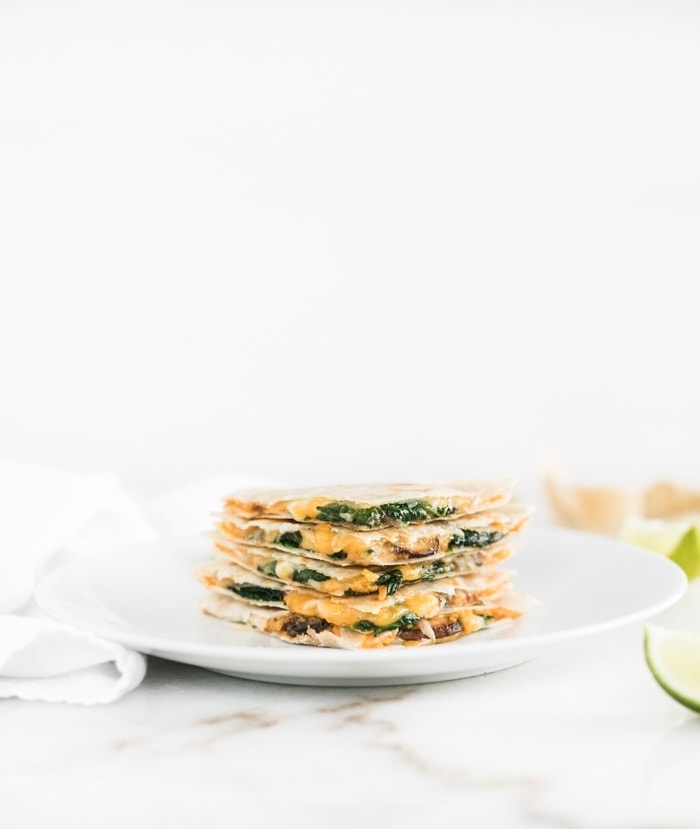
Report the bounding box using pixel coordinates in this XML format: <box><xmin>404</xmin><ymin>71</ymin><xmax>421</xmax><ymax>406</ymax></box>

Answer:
<box><xmin>0</xmin><ymin>586</ymin><xmax>700</xmax><ymax>829</ymax></box>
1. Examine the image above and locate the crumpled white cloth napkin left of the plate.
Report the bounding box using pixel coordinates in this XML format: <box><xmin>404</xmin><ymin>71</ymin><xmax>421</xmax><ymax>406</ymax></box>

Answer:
<box><xmin>0</xmin><ymin>461</ymin><xmax>158</xmax><ymax>704</ymax></box>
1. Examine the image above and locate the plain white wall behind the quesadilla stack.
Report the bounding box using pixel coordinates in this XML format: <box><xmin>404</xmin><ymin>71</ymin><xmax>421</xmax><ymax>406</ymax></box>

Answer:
<box><xmin>0</xmin><ymin>0</ymin><xmax>700</xmax><ymax>498</ymax></box>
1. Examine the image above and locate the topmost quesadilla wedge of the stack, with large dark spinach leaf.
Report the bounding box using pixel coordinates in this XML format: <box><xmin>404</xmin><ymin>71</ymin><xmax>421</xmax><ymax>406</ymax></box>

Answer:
<box><xmin>224</xmin><ymin>478</ymin><xmax>515</xmax><ymax>530</ymax></box>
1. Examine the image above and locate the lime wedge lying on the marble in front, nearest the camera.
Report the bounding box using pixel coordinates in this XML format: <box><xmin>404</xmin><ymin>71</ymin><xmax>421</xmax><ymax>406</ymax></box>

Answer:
<box><xmin>644</xmin><ymin>625</ymin><xmax>700</xmax><ymax>713</ymax></box>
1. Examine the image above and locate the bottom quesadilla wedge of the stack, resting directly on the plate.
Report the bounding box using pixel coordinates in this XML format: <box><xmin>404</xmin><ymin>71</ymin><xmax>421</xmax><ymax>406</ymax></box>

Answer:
<box><xmin>200</xmin><ymin>592</ymin><xmax>534</xmax><ymax>650</ymax></box>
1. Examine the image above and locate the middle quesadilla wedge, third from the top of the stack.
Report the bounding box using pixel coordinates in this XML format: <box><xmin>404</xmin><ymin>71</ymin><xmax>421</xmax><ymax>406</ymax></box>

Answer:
<box><xmin>207</xmin><ymin>539</ymin><xmax>513</xmax><ymax>599</ymax></box>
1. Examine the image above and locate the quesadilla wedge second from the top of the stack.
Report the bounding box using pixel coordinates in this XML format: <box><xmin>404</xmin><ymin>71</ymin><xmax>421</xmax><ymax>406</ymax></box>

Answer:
<box><xmin>215</xmin><ymin>504</ymin><xmax>530</xmax><ymax>566</ymax></box>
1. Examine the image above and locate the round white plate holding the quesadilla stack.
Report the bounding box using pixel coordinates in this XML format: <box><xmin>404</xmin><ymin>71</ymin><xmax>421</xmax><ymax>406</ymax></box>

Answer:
<box><xmin>36</xmin><ymin>527</ymin><xmax>686</xmax><ymax>685</ymax></box>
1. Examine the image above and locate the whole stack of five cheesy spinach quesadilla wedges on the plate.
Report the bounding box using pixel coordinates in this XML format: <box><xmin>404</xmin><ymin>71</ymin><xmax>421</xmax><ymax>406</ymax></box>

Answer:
<box><xmin>195</xmin><ymin>479</ymin><xmax>530</xmax><ymax>649</ymax></box>
